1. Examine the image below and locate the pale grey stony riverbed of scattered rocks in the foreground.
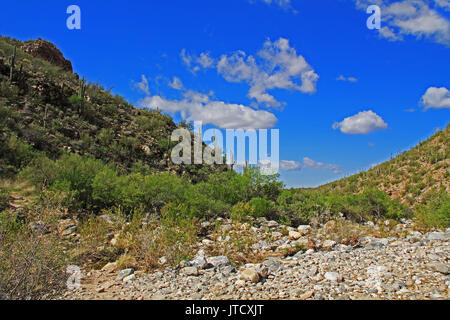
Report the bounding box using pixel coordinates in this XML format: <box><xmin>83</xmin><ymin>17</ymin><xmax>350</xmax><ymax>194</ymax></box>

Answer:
<box><xmin>61</xmin><ymin>219</ymin><xmax>450</xmax><ymax>300</ymax></box>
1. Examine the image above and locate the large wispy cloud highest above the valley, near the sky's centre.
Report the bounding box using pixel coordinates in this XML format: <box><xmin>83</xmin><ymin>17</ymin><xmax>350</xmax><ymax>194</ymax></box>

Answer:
<box><xmin>181</xmin><ymin>38</ymin><xmax>319</xmax><ymax>107</ymax></box>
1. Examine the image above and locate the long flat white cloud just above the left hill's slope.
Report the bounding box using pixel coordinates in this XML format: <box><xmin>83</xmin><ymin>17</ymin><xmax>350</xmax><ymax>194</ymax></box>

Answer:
<box><xmin>138</xmin><ymin>91</ymin><xmax>278</xmax><ymax>129</ymax></box>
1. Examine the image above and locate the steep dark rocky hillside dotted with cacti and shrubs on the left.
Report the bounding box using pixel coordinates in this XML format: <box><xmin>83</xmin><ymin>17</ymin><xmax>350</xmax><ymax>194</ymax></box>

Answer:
<box><xmin>0</xmin><ymin>37</ymin><xmax>224</xmax><ymax>180</ymax></box>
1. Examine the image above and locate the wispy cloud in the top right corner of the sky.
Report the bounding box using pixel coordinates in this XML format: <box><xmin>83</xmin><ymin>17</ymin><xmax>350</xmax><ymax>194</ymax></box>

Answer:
<box><xmin>355</xmin><ymin>0</ymin><xmax>450</xmax><ymax>46</ymax></box>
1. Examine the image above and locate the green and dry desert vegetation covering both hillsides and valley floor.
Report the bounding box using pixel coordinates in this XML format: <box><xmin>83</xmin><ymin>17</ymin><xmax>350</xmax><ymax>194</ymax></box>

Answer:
<box><xmin>0</xmin><ymin>38</ymin><xmax>450</xmax><ymax>299</ymax></box>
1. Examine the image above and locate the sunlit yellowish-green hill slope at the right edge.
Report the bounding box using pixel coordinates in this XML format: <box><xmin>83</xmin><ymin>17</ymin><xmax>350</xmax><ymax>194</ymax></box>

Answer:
<box><xmin>320</xmin><ymin>124</ymin><xmax>450</xmax><ymax>206</ymax></box>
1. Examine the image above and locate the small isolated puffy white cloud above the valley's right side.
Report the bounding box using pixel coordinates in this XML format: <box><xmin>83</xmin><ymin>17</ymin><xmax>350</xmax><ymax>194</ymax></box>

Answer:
<box><xmin>333</xmin><ymin>110</ymin><xmax>388</xmax><ymax>134</ymax></box>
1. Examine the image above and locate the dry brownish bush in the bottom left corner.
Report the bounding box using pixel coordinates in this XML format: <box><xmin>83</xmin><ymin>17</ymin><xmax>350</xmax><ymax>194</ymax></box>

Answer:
<box><xmin>0</xmin><ymin>211</ymin><xmax>67</xmax><ymax>300</ymax></box>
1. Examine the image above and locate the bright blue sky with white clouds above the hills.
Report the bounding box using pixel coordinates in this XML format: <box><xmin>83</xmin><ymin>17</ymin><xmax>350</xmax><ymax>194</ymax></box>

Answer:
<box><xmin>0</xmin><ymin>0</ymin><xmax>450</xmax><ymax>187</ymax></box>
